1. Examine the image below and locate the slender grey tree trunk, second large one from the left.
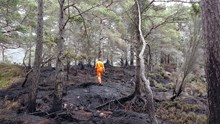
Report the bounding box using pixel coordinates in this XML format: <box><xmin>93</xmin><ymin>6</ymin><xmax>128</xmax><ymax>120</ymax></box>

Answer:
<box><xmin>51</xmin><ymin>0</ymin><xmax>65</xmax><ymax>112</ymax></box>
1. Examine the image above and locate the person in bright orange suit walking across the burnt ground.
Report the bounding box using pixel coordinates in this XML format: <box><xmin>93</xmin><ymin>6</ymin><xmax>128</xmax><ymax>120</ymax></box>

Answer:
<box><xmin>95</xmin><ymin>58</ymin><xmax>105</xmax><ymax>84</ymax></box>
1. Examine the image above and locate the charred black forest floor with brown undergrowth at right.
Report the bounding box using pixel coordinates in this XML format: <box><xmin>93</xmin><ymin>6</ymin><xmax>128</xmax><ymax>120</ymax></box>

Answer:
<box><xmin>0</xmin><ymin>66</ymin><xmax>207</xmax><ymax>124</ymax></box>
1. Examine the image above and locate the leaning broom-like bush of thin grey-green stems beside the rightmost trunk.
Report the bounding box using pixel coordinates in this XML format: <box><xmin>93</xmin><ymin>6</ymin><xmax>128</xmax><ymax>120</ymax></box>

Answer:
<box><xmin>173</xmin><ymin>5</ymin><xmax>201</xmax><ymax>100</ymax></box>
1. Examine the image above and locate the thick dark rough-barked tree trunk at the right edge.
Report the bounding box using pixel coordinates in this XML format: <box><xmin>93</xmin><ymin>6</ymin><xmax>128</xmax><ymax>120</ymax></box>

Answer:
<box><xmin>202</xmin><ymin>0</ymin><xmax>220</xmax><ymax>124</ymax></box>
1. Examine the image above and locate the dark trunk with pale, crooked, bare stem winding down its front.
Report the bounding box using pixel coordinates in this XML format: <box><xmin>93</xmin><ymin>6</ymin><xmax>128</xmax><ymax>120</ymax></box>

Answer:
<box><xmin>135</xmin><ymin>0</ymin><xmax>157</xmax><ymax>124</ymax></box>
